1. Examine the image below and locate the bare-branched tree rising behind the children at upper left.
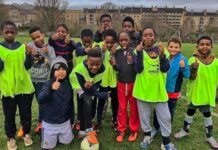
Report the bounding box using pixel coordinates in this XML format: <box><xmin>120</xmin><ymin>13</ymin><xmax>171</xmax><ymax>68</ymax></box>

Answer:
<box><xmin>35</xmin><ymin>0</ymin><xmax>67</xmax><ymax>32</ymax></box>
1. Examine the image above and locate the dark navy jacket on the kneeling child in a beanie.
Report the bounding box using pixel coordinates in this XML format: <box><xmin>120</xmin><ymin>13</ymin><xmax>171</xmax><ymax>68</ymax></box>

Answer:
<box><xmin>38</xmin><ymin>78</ymin><xmax>73</xmax><ymax>124</ymax></box>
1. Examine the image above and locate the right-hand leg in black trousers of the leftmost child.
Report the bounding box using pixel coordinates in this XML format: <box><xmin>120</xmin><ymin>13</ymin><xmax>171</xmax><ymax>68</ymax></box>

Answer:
<box><xmin>15</xmin><ymin>94</ymin><xmax>33</xmax><ymax>135</ymax></box>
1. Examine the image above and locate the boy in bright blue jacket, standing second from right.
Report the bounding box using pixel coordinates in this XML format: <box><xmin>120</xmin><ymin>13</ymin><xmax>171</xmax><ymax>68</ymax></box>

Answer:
<box><xmin>151</xmin><ymin>38</ymin><xmax>190</xmax><ymax>138</ymax></box>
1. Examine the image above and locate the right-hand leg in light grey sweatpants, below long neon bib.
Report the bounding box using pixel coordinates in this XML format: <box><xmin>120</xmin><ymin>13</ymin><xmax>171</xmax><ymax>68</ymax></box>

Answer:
<box><xmin>155</xmin><ymin>102</ymin><xmax>171</xmax><ymax>145</ymax></box>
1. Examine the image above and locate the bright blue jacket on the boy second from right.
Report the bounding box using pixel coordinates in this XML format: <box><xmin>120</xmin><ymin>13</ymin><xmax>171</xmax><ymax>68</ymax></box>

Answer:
<box><xmin>166</xmin><ymin>53</ymin><xmax>190</xmax><ymax>93</ymax></box>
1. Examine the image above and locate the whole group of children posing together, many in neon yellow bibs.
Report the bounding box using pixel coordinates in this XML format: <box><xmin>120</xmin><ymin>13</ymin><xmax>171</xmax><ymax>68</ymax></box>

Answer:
<box><xmin>0</xmin><ymin>14</ymin><xmax>218</xmax><ymax>150</ymax></box>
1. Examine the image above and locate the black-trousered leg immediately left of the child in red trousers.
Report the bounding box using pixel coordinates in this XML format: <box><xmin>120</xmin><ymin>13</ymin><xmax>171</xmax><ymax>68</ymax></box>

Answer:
<box><xmin>110</xmin><ymin>88</ymin><xmax>119</xmax><ymax>123</ymax></box>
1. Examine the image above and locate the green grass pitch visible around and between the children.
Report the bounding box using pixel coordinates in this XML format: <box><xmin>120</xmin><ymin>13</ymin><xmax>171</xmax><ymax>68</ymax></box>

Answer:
<box><xmin>0</xmin><ymin>35</ymin><xmax>218</xmax><ymax>150</ymax></box>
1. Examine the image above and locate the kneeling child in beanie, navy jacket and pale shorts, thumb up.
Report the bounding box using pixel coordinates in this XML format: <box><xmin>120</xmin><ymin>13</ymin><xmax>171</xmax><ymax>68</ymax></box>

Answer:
<box><xmin>38</xmin><ymin>56</ymin><xmax>73</xmax><ymax>149</ymax></box>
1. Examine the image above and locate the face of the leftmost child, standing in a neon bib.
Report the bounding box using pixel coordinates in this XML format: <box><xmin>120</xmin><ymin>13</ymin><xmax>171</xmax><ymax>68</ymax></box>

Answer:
<box><xmin>2</xmin><ymin>25</ymin><xmax>17</xmax><ymax>43</ymax></box>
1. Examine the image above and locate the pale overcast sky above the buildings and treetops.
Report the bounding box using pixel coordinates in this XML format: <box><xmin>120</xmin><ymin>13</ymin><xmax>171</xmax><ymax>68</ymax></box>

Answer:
<box><xmin>4</xmin><ymin>0</ymin><xmax>218</xmax><ymax>11</ymax></box>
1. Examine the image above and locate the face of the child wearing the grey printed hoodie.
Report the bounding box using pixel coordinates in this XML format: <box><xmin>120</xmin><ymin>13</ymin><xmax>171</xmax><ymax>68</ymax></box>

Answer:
<box><xmin>30</xmin><ymin>31</ymin><xmax>44</xmax><ymax>47</ymax></box>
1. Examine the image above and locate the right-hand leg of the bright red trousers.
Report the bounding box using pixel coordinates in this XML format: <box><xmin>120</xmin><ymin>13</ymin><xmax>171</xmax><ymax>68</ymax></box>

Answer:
<box><xmin>127</xmin><ymin>84</ymin><xmax>140</xmax><ymax>132</ymax></box>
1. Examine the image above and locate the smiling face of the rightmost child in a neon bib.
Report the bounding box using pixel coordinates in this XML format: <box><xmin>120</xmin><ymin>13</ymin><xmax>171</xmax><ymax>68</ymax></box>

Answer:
<box><xmin>196</xmin><ymin>39</ymin><xmax>213</xmax><ymax>54</ymax></box>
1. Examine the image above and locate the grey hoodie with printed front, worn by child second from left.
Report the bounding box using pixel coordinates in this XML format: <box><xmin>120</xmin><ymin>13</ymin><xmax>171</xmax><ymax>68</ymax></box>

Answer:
<box><xmin>27</xmin><ymin>42</ymin><xmax>56</xmax><ymax>82</ymax></box>
